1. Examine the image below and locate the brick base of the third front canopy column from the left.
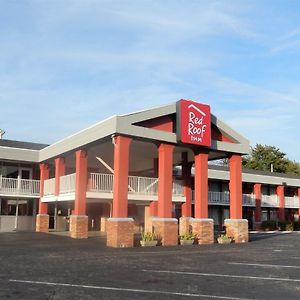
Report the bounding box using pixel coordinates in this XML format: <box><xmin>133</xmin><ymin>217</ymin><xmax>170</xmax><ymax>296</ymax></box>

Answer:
<box><xmin>191</xmin><ymin>219</ymin><xmax>214</xmax><ymax>245</ymax></box>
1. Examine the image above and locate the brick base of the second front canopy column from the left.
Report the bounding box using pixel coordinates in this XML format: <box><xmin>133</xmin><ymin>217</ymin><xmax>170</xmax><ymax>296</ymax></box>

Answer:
<box><xmin>152</xmin><ymin>217</ymin><xmax>178</xmax><ymax>246</ymax></box>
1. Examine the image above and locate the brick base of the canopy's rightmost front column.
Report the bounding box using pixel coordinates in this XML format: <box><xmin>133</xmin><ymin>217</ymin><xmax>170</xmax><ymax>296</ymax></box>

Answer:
<box><xmin>224</xmin><ymin>219</ymin><xmax>249</xmax><ymax>243</ymax></box>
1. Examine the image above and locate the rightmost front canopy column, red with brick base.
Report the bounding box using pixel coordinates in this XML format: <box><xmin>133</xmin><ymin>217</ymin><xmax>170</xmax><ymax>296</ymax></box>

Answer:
<box><xmin>224</xmin><ymin>154</ymin><xmax>249</xmax><ymax>243</ymax></box>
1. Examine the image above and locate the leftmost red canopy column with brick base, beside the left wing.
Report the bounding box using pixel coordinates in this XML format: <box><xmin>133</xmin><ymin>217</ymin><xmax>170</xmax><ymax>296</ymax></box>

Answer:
<box><xmin>35</xmin><ymin>163</ymin><xmax>49</xmax><ymax>232</ymax></box>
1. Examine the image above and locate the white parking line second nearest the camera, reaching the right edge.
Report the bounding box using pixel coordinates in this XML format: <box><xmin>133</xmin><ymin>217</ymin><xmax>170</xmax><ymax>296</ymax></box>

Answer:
<box><xmin>142</xmin><ymin>270</ymin><xmax>300</xmax><ymax>282</ymax></box>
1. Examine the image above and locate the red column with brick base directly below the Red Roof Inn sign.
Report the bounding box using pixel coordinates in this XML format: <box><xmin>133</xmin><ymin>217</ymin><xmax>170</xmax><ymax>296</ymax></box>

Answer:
<box><xmin>191</xmin><ymin>152</ymin><xmax>214</xmax><ymax>244</ymax></box>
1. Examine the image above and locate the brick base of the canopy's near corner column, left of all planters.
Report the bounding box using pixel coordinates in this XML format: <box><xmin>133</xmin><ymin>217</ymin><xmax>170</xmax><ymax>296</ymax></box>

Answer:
<box><xmin>106</xmin><ymin>218</ymin><xmax>134</xmax><ymax>248</ymax></box>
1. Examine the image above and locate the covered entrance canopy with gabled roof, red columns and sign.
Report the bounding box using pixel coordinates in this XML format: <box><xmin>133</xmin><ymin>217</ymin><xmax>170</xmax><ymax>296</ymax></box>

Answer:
<box><xmin>39</xmin><ymin>100</ymin><xmax>249</xmax><ymax>244</ymax></box>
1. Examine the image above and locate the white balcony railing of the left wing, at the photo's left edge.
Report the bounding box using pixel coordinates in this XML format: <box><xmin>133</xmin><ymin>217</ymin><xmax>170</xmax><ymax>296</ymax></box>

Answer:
<box><xmin>0</xmin><ymin>176</ymin><xmax>40</xmax><ymax>196</ymax></box>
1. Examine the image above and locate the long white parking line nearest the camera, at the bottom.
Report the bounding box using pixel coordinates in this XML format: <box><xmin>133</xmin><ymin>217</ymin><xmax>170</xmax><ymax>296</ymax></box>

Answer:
<box><xmin>9</xmin><ymin>279</ymin><xmax>250</xmax><ymax>300</ymax></box>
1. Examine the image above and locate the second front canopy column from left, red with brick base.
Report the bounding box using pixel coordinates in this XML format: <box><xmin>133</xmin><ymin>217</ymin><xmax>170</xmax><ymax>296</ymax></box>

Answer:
<box><xmin>152</xmin><ymin>144</ymin><xmax>178</xmax><ymax>246</ymax></box>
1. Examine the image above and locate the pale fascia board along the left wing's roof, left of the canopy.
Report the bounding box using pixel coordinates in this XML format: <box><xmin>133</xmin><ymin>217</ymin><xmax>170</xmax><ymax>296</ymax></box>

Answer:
<box><xmin>0</xmin><ymin>146</ymin><xmax>39</xmax><ymax>162</ymax></box>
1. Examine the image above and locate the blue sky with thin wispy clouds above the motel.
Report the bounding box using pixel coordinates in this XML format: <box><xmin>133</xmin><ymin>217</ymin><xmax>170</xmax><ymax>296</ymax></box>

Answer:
<box><xmin>0</xmin><ymin>0</ymin><xmax>300</xmax><ymax>162</ymax></box>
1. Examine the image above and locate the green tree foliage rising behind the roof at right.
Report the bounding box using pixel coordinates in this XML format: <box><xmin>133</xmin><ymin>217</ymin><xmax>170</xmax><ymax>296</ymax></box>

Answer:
<box><xmin>243</xmin><ymin>144</ymin><xmax>300</xmax><ymax>175</ymax></box>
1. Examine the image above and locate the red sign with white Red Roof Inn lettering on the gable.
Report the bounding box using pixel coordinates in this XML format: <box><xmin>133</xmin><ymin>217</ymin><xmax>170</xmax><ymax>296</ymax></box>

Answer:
<box><xmin>177</xmin><ymin>100</ymin><xmax>211</xmax><ymax>147</ymax></box>
